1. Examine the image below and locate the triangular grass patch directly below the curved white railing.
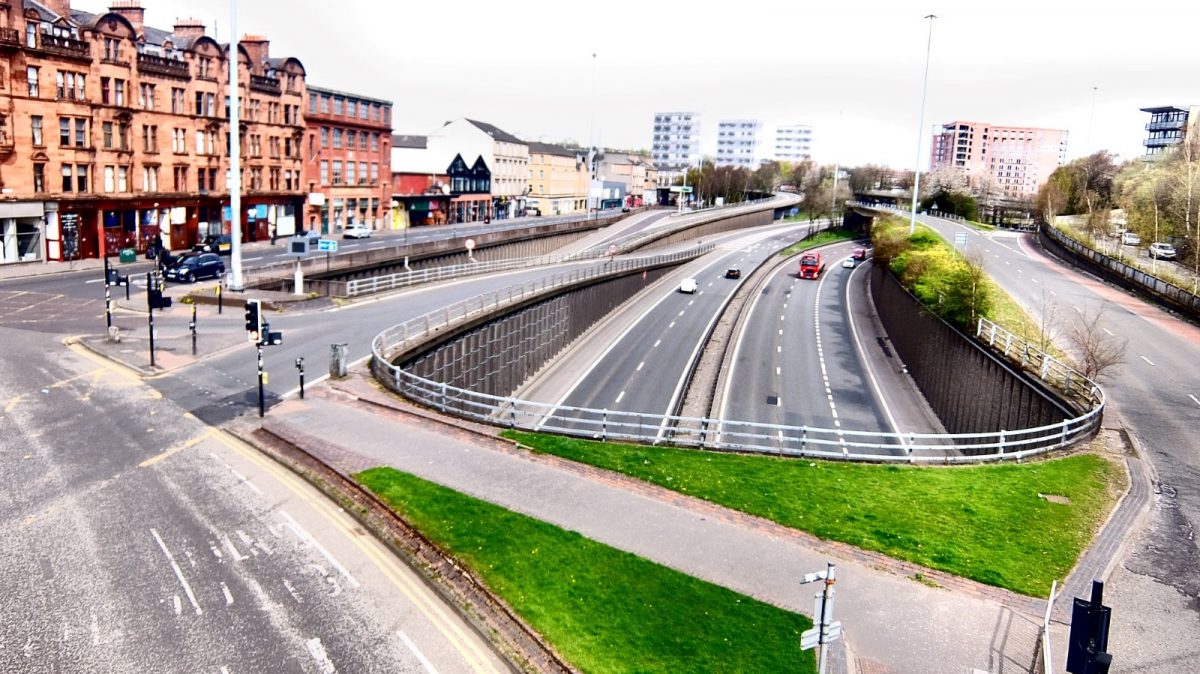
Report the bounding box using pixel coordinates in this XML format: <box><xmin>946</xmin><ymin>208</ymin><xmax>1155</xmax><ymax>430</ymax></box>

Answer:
<box><xmin>504</xmin><ymin>431</ymin><xmax>1121</xmax><ymax>597</ymax></box>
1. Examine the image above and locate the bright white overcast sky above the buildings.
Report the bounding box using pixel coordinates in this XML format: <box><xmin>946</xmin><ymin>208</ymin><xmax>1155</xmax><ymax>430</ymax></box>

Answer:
<box><xmin>82</xmin><ymin>0</ymin><xmax>1200</xmax><ymax>170</ymax></box>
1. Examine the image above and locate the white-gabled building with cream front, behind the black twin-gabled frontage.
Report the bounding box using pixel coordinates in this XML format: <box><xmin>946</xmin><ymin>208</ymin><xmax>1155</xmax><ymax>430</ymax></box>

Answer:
<box><xmin>427</xmin><ymin>119</ymin><xmax>529</xmax><ymax>219</ymax></box>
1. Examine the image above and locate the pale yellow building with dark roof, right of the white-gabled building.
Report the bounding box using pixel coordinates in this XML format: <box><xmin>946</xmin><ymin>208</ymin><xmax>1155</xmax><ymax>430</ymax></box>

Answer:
<box><xmin>526</xmin><ymin>142</ymin><xmax>588</xmax><ymax>216</ymax></box>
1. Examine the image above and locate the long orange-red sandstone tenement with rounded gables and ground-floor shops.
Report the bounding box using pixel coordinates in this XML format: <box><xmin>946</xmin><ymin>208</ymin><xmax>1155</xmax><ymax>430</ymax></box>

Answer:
<box><xmin>0</xmin><ymin>0</ymin><xmax>305</xmax><ymax>261</ymax></box>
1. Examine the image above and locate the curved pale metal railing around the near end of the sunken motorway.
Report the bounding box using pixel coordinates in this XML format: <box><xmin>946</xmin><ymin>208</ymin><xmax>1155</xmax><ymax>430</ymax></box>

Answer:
<box><xmin>371</xmin><ymin>251</ymin><xmax>1104</xmax><ymax>463</ymax></box>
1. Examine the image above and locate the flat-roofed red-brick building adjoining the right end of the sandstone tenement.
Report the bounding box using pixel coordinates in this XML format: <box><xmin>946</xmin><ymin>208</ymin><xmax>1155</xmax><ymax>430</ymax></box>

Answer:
<box><xmin>304</xmin><ymin>86</ymin><xmax>392</xmax><ymax>234</ymax></box>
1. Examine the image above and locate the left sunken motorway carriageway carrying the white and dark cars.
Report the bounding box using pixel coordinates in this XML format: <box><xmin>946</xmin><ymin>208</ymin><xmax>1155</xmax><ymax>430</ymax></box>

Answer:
<box><xmin>553</xmin><ymin>225</ymin><xmax>816</xmax><ymax>436</ymax></box>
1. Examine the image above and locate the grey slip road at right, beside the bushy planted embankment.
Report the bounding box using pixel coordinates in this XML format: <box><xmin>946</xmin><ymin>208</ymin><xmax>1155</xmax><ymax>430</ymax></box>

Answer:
<box><xmin>907</xmin><ymin>211</ymin><xmax>1200</xmax><ymax>673</ymax></box>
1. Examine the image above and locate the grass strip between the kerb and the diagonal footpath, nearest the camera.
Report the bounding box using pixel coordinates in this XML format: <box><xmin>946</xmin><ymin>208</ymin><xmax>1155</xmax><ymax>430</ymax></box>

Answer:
<box><xmin>356</xmin><ymin>468</ymin><xmax>816</xmax><ymax>673</ymax></box>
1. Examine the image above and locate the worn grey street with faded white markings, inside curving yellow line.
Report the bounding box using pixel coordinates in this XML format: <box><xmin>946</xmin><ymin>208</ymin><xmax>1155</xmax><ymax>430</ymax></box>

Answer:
<box><xmin>0</xmin><ymin>329</ymin><xmax>506</xmax><ymax>673</ymax></box>
